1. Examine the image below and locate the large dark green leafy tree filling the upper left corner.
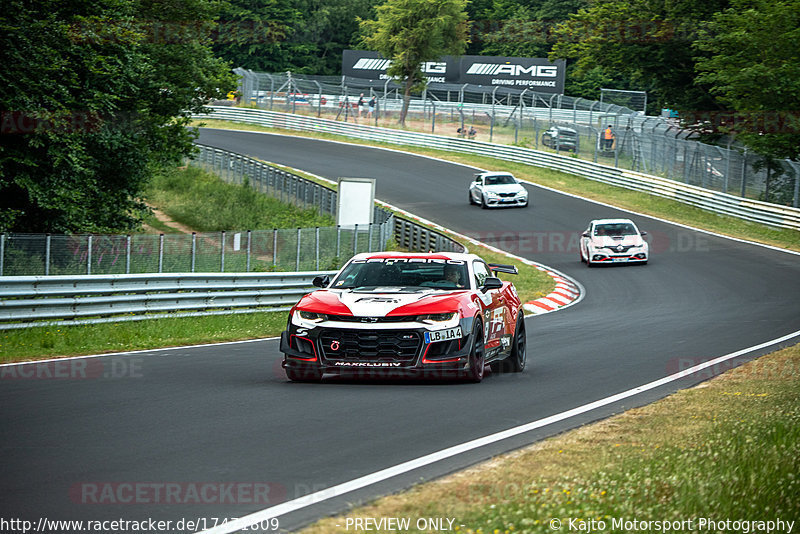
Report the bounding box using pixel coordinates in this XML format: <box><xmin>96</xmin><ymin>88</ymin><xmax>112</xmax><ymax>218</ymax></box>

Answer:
<box><xmin>0</xmin><ymin>0</ymin><xmax>235</xmax><ymax>232</ymax></box>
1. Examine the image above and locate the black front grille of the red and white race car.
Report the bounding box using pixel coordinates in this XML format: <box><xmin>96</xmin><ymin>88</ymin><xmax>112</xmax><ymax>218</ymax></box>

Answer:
<box><xmin>319</xmin><ymin>328</ymin><xmax>422</xmax><ymax>363</ymax></box>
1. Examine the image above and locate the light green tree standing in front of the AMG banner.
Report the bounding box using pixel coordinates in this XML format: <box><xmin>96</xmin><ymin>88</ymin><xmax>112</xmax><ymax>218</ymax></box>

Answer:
<box><xmin>360</xmin><ymin>0</ymin><xmax>468</xmax><ymax>125</ymax></box>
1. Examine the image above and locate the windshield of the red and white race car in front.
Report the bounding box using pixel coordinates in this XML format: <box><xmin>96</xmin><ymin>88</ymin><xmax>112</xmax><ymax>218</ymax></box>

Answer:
<box><xmin>330</xmin><ymin>259</ymin><xmax>469</xmax><ymax>291</ymax></box>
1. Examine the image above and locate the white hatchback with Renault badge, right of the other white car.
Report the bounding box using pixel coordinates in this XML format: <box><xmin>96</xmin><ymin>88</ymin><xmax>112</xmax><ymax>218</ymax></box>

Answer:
<box><xmin>580</xmin><ymin>219</ymin><xmax>650</xmax><ymax>267</ymax></box>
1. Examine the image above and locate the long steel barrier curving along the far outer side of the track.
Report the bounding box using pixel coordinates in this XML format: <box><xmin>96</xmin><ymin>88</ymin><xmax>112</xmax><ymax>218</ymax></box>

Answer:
<box><xmin>196</xmin><ymin>106</ymin><xmax>800</xmax><ymax>230</ymax></box>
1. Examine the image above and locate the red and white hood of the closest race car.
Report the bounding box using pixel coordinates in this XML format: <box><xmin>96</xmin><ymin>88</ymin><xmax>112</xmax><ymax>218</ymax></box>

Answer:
<box><xmin>297</xmin><ymin>288</ymin><xmax>467</xmax><ymax>317</ymax></box>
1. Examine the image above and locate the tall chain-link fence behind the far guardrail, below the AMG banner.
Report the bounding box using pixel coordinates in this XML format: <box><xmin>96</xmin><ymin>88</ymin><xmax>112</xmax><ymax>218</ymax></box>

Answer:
<box><xmin>231</xmin><ymin>69</ymin><xmax>800</xmax><ymax>207</ymax></box>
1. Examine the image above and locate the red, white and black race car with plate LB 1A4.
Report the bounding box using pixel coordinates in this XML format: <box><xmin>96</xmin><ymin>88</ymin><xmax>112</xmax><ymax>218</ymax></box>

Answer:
<box><xmin>280</xmin><ymin>252</ymin><xmax>525</xmax><ymax>382</ymax></box>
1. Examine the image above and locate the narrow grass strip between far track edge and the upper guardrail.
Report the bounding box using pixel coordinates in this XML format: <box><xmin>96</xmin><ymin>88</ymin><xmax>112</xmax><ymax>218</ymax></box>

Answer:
<box><xmin>195</xmin><ymin>120</ymin><xmax>800</xmax><ymax>251</ymax></box>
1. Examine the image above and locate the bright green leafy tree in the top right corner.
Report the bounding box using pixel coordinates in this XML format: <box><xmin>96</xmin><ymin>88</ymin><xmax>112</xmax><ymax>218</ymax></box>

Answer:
<box><xmin>695</xmin><ymin>0</ymin><xmax>800</xmax><ymax>160</ymax></box>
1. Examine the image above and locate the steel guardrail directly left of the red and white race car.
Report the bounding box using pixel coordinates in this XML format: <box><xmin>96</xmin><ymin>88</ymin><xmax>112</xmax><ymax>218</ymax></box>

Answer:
<box><xmin>0</xmin><ymin>271</ymin><xmax>336</xmax><ymax>330</ymax></box>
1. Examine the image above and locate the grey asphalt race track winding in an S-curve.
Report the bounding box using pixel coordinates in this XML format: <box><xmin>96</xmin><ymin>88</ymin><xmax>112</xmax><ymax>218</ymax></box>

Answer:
<box><xmin>0</xmin><ymin>130</ymin><xmax>800</xmax><ymax>531</ymax></box>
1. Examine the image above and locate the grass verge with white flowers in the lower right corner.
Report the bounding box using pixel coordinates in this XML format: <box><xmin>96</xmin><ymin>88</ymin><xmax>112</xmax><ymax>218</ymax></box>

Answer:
<box><xmin>302</xmin><ymin>345</ymin><xmax>800</xmax><ymax>534</ymax></box>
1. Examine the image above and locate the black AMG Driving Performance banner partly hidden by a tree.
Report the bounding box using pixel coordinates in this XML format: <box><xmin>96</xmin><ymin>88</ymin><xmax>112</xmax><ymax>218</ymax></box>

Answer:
<box><xmin>342</xmin><ymin>50</ymin><xmax>566</xmax><ymax>94</ymax></box>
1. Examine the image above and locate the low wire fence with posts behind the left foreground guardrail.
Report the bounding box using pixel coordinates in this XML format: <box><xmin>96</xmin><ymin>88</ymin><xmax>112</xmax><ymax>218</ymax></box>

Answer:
<box><xmin>0</xmin><ymin>225</ymin><xmax>392</xmax><ymax>276</ymax></box>
